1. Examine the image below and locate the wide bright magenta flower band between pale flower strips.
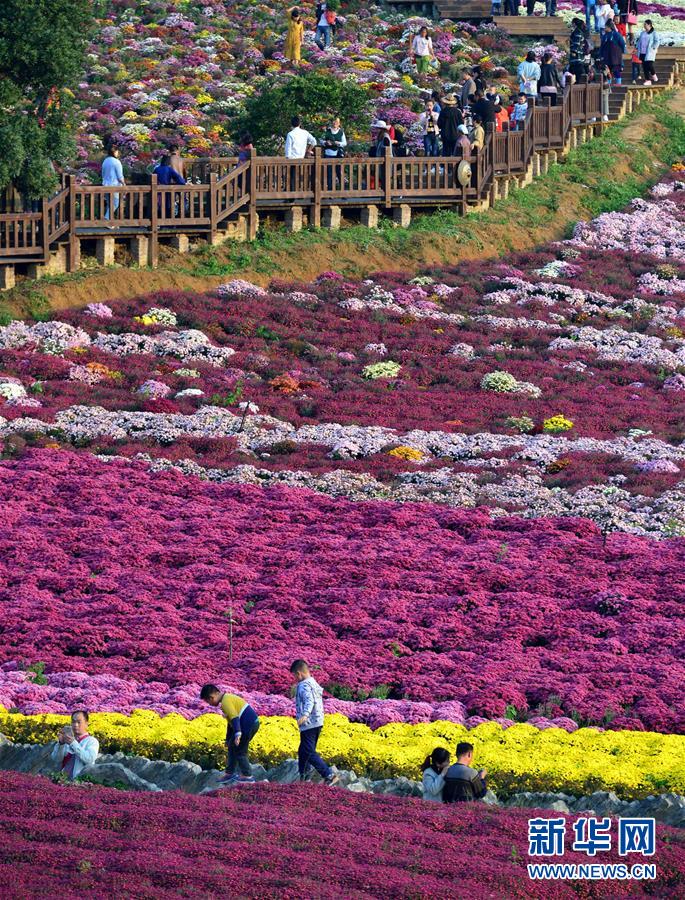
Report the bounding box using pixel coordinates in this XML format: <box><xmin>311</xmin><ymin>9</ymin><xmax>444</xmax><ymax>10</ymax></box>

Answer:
<box><xmin>0</xmin><ymin>451</ymin><xmax>685</xmax><ymax>733</ymax></box>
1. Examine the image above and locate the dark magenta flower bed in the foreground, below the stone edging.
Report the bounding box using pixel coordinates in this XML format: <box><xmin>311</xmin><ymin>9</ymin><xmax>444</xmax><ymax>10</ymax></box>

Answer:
<box><xmin>0</xmin><ymin>772</ymin><xmax>685</xmax><ymax>900</ymax></box>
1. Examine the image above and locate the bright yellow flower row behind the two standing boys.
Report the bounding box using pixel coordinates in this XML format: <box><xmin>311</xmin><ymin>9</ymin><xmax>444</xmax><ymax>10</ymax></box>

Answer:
<box><xmin>0</xmin><ymin>707</ymin><xmax>685</xmax><ymax>799</ymax></box>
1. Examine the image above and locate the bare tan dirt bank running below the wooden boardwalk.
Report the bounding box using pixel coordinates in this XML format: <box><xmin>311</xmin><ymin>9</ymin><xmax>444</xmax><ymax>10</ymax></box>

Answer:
<box><xmin>5</xmin><ymin>88</ymin><xmax>685</xmax><ymax>315</ymax></box>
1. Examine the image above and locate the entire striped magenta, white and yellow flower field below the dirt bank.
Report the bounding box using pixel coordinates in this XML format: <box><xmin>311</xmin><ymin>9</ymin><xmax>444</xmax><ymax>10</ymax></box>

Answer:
<box><xmin>0</xmin><ymin>173</ymin><xmax>685</xmax><ymax>897</ymax></box>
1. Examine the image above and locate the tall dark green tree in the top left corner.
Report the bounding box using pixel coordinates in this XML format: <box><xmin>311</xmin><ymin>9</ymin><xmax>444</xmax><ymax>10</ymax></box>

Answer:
<box><xmin>0</xmin><ymin>0</ymin><xmax>93</xmax><ymax>197</ymax></box>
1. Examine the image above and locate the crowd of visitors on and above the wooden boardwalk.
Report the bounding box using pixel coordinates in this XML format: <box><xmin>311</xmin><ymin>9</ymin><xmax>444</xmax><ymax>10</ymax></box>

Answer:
<box><xmin>96</xmin><ymin>0</ymin><xmax>659</xmax><ymax>185</ymax></box>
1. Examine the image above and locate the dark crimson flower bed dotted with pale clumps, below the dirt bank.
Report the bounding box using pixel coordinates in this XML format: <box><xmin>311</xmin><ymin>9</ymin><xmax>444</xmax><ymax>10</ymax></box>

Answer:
<box><xmin>0</xmin><ymin>243</ymin><xmax>685</xmax><ymax>442</ymax></box>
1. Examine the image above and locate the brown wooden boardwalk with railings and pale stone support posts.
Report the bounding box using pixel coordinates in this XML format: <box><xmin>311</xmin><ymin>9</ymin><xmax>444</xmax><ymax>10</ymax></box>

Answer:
<box><xmin>0</xmin><ymin>62</ymin><xmax>677</xmax><ymax>289</ymax></box>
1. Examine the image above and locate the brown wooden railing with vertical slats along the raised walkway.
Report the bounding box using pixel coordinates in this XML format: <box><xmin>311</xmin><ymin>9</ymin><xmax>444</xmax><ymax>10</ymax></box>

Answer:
<box><xmin>0</xmin><ymin>84</ymin><xmax>601</xmax><ymax>265</ymax></box>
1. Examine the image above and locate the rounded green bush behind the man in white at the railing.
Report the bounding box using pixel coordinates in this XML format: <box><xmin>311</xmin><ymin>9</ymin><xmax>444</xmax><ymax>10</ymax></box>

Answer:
<box><xmin>237</xmin><ymin>72</ymin><xmax>369</xmax><ymax>153</ymax></box>
